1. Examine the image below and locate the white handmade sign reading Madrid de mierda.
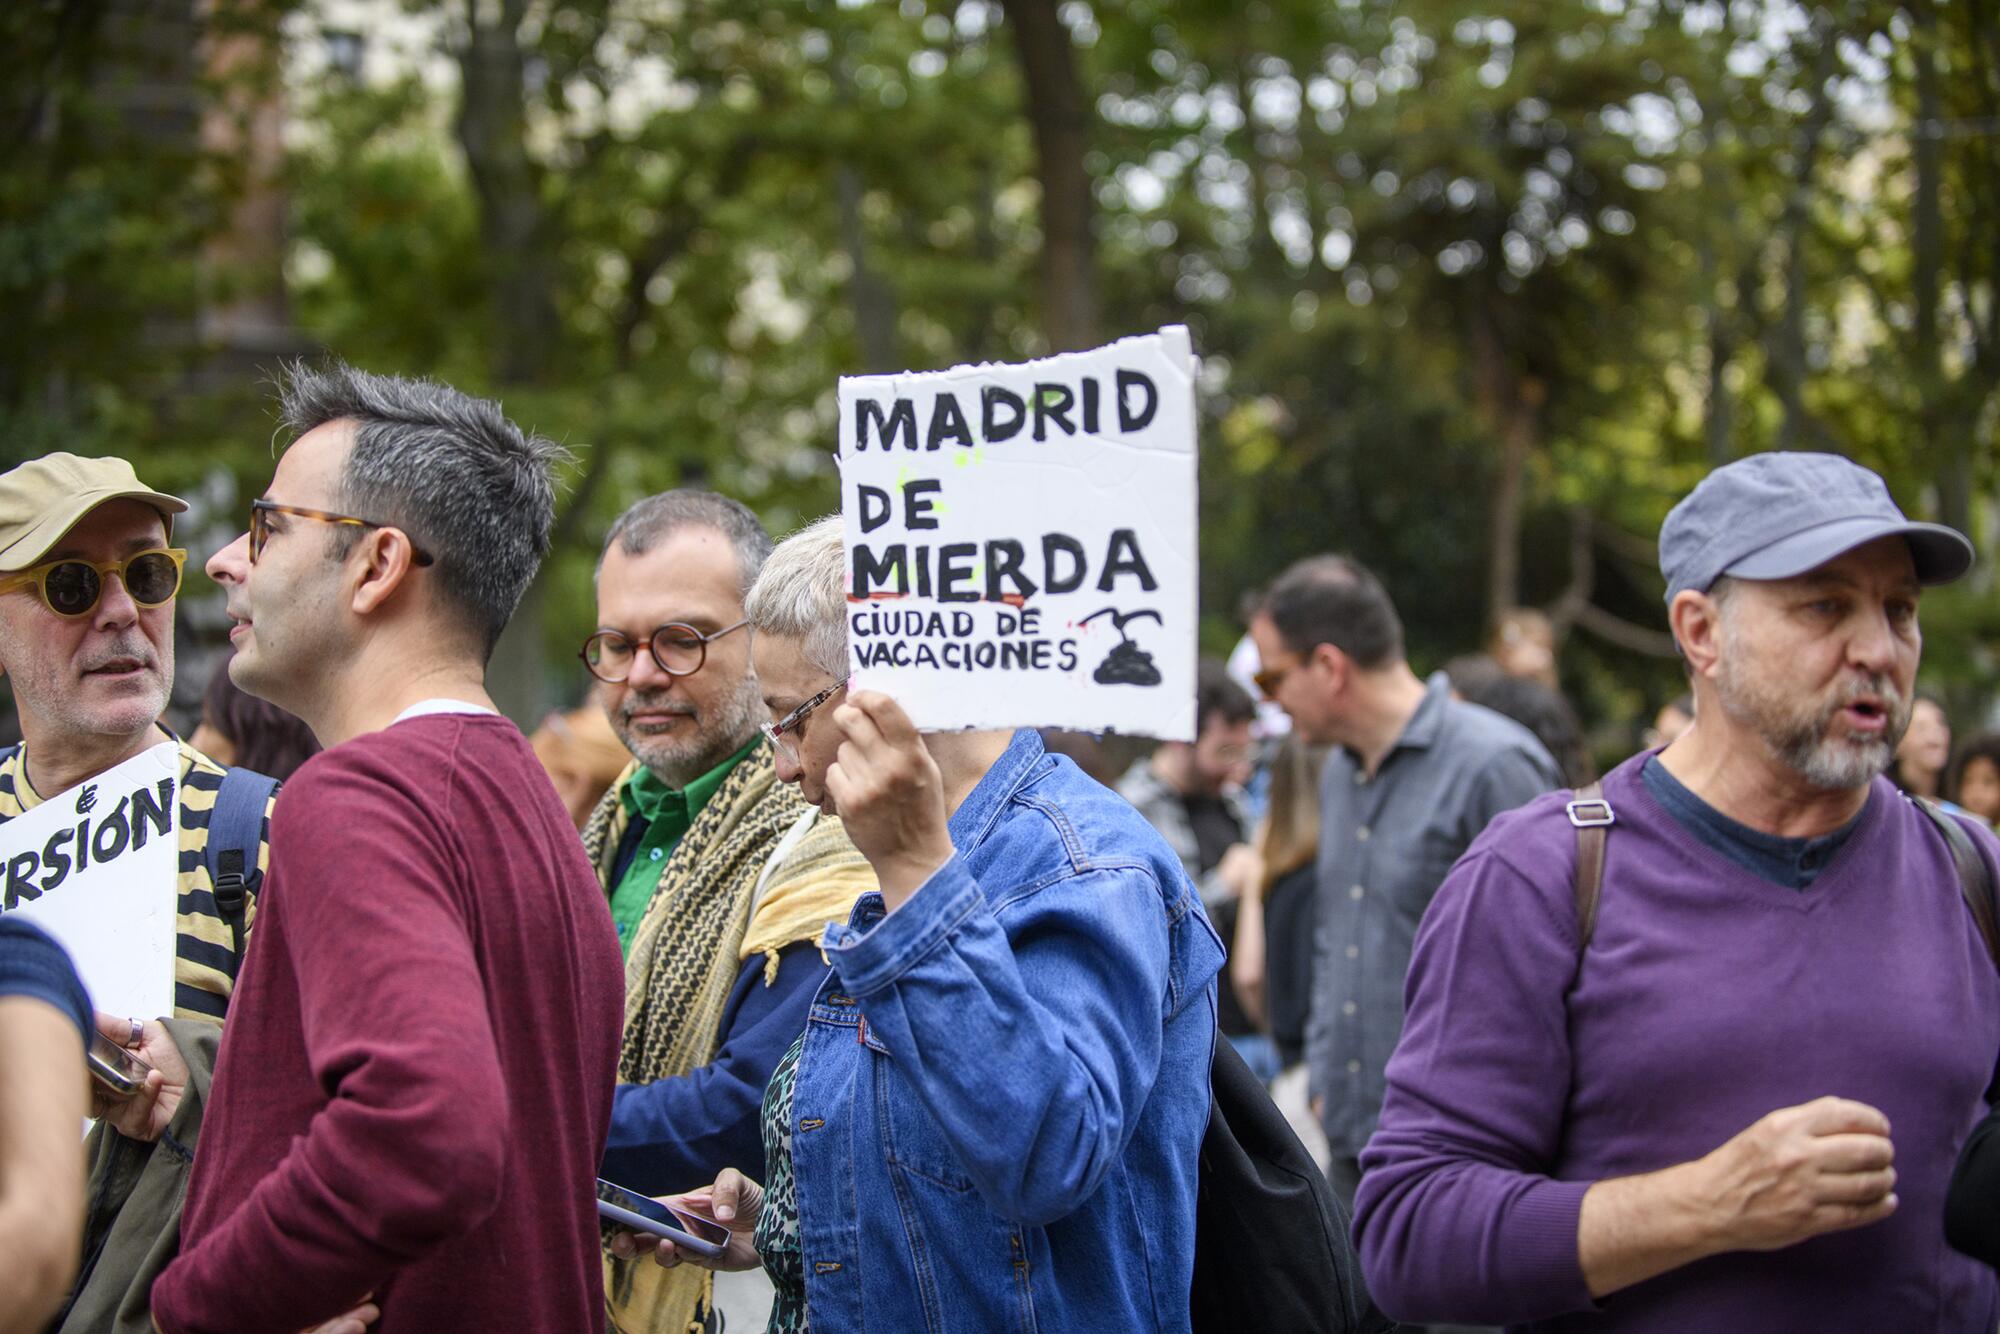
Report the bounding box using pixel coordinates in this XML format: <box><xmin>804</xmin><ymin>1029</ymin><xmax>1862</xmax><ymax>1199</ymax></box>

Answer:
<box><xmin>840</xmin><ymin>326</ymin><xmax>1196</xmax><ymax>742</ymax></box>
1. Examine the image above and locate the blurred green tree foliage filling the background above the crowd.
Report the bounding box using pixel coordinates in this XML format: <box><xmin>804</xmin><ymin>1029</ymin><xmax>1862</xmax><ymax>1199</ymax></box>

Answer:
<box><xmin>0</xmin><ymin>0</ymin><xmax>2000</xmax><ymax>740</ymax></box>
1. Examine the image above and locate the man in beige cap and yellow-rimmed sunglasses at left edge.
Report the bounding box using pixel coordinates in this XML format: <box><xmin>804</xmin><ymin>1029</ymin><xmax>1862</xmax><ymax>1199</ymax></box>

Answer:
<box><xmin>0</xmin><ymin>454</ymin><xmax>274</xmax><ymax>1334</ymax></box>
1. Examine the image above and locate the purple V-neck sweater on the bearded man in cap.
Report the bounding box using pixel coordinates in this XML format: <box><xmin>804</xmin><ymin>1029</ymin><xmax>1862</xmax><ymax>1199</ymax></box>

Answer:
<box><xmin>1354</xmin><ymin>756</ymin><xmax>2000</xmax><ymax>1334</ymax></box>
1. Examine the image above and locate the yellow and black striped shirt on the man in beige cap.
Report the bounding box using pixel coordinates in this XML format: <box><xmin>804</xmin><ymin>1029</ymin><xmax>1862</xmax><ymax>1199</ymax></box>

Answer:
<box><xmin>0</xmin><ymin>736</ymin><xmax>276</xmax><ymax>1020</ymax></box>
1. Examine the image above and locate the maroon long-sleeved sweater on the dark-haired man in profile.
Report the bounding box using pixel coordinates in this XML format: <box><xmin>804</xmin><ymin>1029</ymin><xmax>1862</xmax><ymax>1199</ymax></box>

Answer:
<box><xmin>152</xmin><ymin>714</ymin><xmax>624</xmax><ymax>1334</ymax></box>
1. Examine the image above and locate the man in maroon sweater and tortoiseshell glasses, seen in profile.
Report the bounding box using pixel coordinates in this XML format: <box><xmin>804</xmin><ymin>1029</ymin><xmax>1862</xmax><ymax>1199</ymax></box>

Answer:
<box><xmin>152</xmin><ymin>366</ymin><xmax>624</xmax><ymax>1334</ymax></box>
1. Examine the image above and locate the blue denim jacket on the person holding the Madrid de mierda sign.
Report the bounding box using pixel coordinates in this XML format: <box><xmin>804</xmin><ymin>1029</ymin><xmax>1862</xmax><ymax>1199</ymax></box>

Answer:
<box><xmin>792</xmin><ymin>732</ymin><xmax>1222</xmax><ymax>1334</ymax></box>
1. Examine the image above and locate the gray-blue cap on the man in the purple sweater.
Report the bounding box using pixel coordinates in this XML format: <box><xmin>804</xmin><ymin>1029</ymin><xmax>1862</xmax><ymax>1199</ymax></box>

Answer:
<box><xmin>1660</xmin><ymin>450</ymin><xmax>1972</xmax><ymax>602</ymax></box>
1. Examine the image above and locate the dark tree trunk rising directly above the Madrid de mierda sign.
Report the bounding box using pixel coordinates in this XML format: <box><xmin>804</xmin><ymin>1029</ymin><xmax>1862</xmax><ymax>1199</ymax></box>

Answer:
<box><xmin>1000</xmin><ymin>0</ymin><xmax>1098</xmax><ymax>352</ymax></box>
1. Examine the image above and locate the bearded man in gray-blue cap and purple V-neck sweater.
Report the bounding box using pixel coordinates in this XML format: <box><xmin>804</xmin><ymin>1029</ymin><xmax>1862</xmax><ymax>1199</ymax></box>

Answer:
<box><xmin>1354</xmin><ymin>454</ymin><xmax>2000</xmax><ymax>1334</ymax></box>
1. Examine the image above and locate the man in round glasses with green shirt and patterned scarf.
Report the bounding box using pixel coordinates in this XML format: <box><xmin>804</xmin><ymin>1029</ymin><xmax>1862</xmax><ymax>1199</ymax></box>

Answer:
<box><xmin>580</xmin><ymin>490</ymin><xmax>874</xmax><ymax>1330</ymax></box>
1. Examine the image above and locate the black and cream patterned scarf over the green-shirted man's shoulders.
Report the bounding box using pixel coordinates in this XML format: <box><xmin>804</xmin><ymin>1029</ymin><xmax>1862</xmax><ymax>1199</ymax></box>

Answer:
<box><xmin>584</xmin><ymin>746</ymin><xmax>812</xmax><ymax>1334</ymax></box>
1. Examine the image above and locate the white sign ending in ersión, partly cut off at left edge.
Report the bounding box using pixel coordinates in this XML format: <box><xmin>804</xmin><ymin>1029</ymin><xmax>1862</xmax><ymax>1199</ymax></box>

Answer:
<box><xmin>0</xmin><ymin>742</ymin><xmax>180</xmax><ymax>1016</ymax></box>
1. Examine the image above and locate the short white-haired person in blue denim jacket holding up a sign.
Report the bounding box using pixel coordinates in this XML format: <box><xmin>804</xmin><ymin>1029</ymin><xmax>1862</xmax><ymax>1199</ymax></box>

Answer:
<box><xmin>620</xmin><ymin>518</ymin><xmax>1222</xmax><ymax>1334</ymax></box>
